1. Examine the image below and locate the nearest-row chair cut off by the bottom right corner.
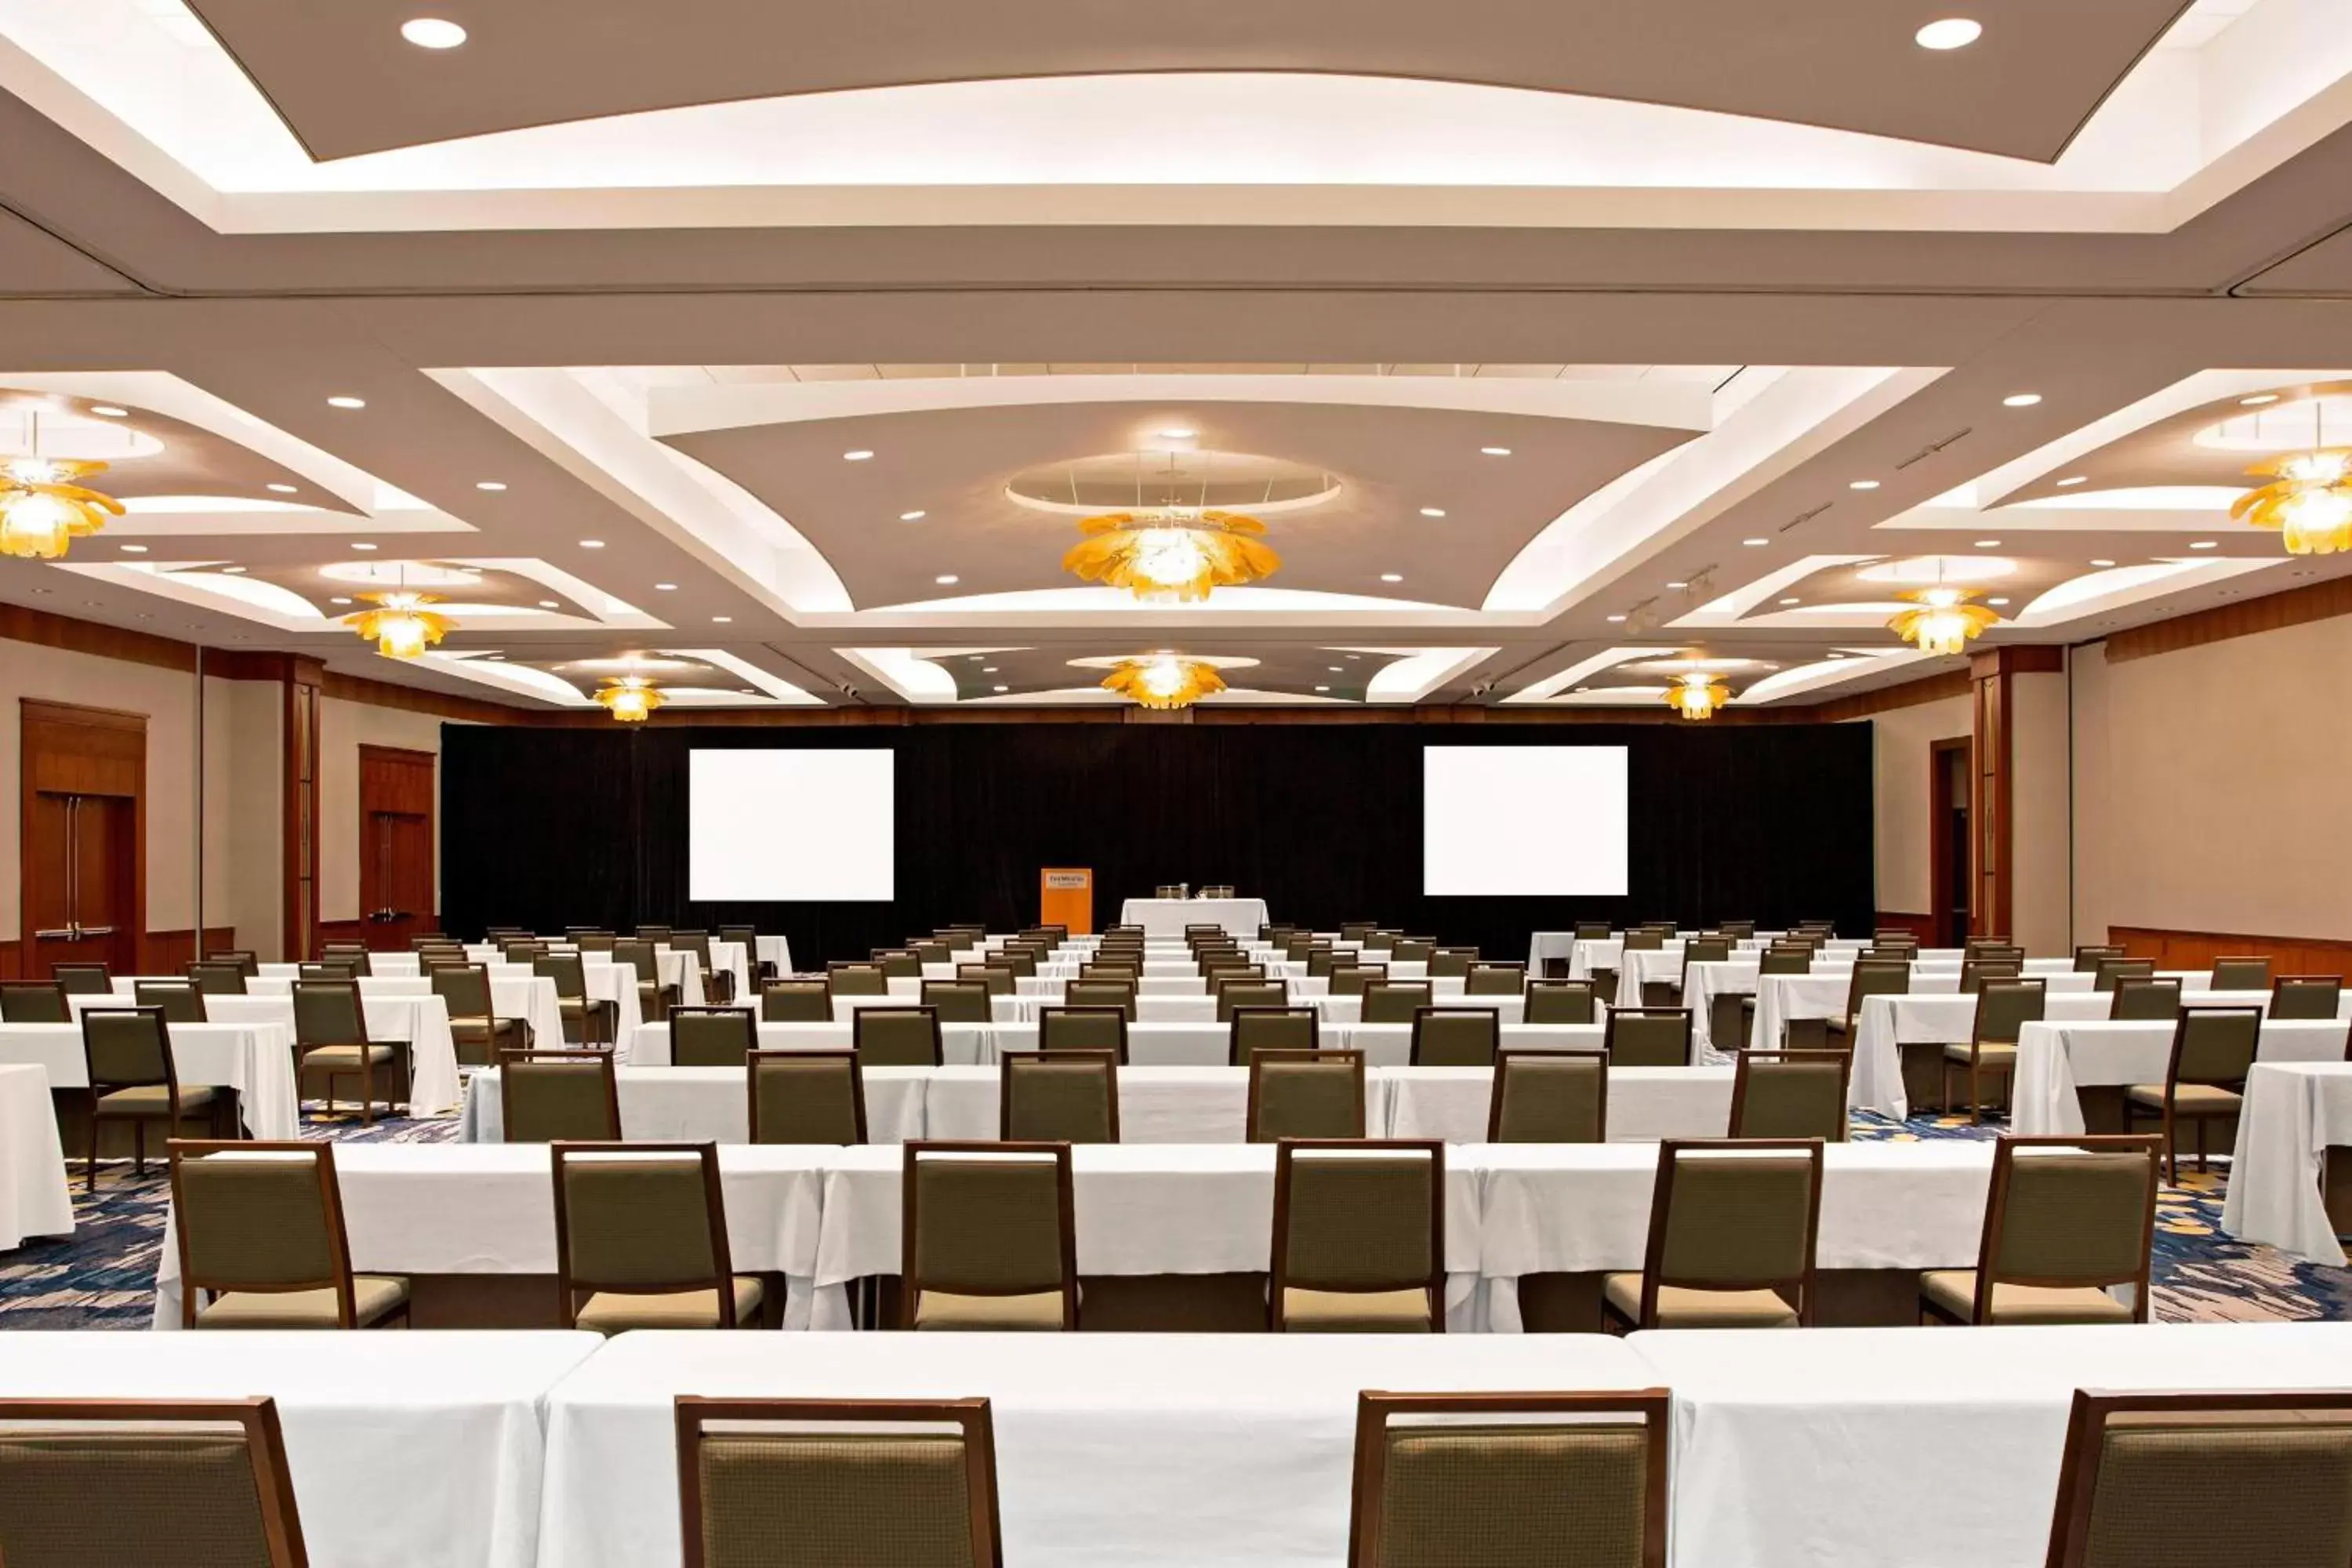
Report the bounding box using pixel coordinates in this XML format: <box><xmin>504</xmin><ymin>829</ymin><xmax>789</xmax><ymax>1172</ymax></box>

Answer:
<box><xmin>2044</xmin><ymin>1389</ymin><xmax>2352</xmax><ymax>1568</ymax></box>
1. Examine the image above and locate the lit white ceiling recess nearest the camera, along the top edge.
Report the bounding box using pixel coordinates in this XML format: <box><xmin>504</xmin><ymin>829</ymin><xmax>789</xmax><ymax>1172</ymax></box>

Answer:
<box><xmin>0</xmin><ymin>0</ymin><xmax>2352</xmax><ymax>233</ymax></box>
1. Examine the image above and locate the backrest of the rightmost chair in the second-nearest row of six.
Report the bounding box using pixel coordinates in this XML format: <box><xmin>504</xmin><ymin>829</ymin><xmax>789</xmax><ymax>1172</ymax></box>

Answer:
<box><xmin>1976</xmin><ymin>1133</ymin><xmax>2164</xmax><ymax>1323</ymax></box>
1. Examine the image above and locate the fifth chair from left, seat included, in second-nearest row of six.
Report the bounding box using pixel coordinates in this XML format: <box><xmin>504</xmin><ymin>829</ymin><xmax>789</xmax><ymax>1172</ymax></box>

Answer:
<box><xmin>1602</xmin><ymin>1138</ymin><xmax>1820</xmax><ymax>1330</ymax></box>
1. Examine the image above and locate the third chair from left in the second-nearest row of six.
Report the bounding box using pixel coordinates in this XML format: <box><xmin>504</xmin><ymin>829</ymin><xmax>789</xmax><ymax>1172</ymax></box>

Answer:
<box><xmin>898</xmin><ymin>1142</ymin><xmax>1077</xmax><ymax>1335</ymax></box>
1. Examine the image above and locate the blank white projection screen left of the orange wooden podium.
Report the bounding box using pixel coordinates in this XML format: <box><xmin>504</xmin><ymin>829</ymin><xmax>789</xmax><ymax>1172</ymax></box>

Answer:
<box><xmin>687</xmin><ymin>750</ymin><xmax>898</xmax><ymax>902</ymax></box>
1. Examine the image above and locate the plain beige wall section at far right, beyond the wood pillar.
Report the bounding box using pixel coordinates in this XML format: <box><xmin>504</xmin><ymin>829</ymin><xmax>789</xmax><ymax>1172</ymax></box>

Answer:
<box><xmin>2074</xmin><ymin>616</ymin><xmax>2352</xmax><ymax>940</ymax></box>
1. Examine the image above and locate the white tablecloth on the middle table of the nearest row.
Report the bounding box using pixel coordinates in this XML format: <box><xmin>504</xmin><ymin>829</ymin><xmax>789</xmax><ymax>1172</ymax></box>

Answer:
<box><xmin>541</xmin><ymin>1335</ymin><xmax>1651</xmax><ymax>1568</ymax></box>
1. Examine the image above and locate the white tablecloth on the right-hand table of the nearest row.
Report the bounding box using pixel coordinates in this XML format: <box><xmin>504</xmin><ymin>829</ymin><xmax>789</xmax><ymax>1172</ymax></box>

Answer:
<box><xmin>1630</xmin><ymin>1326</ymin><xmax>2352</xmax><ymax>1568</ymax></box>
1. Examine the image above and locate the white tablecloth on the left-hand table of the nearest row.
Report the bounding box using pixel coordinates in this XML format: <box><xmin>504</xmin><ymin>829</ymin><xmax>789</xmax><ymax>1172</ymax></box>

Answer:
<box><xmin>0</xmin><ymin>1330</ymin><xmax>602</xmax><ymax>1568</ymax></box>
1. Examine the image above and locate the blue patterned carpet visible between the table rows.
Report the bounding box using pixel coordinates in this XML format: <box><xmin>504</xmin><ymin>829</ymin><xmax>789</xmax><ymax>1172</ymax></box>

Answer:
<box><xmin>0</xmin><ymin>1112</ymin><xmax>2352</xmax><ymax>1328</ymax></box>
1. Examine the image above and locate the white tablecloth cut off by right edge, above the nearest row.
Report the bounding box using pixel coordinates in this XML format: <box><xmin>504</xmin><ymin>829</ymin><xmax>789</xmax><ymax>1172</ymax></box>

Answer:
<box><xmin>2220</xmin><ymin>1062</ymin><xmax>2352</xmax><ymax>1269</ymax></box>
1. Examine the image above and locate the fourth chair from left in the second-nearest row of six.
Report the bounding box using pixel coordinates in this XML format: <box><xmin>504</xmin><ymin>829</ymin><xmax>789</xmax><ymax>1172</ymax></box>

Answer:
<box><xmin>1261</xmin><ymin>1142</ymin><xmax>1446</xmax><ymax>1333</ymax></box>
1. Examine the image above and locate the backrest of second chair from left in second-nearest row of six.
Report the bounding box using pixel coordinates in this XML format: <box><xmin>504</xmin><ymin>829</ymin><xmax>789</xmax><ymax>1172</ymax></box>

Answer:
<box><xmin>548</xmin><ymin>1142</ymin><xmax>736</xmax><ymax>1328</ymax></box>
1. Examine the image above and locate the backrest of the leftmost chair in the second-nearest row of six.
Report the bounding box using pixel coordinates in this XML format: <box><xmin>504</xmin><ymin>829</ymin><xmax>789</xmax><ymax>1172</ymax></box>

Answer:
<box><xmin>167</xmin><ymin>1138</ymin><xmax>355</xmax><ymax>1328</ymax></box>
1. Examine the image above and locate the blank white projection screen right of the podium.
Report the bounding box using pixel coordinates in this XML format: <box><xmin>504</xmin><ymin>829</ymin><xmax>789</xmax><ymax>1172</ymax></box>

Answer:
<box><xmin>1421</xmin><ymin>746</ymin><xmax>1632</xmax><ymax>898</ymax></box>
